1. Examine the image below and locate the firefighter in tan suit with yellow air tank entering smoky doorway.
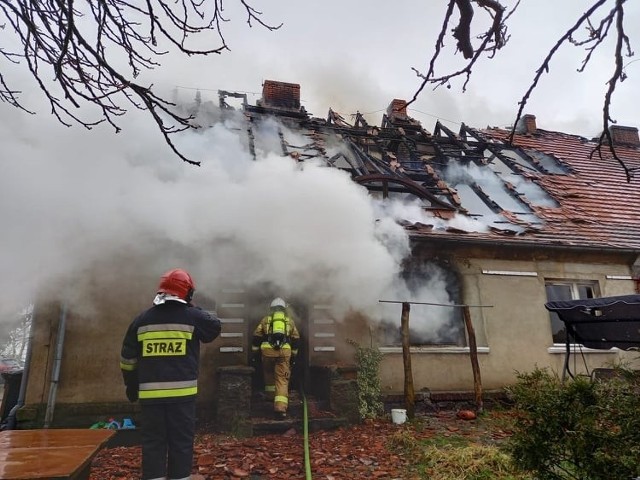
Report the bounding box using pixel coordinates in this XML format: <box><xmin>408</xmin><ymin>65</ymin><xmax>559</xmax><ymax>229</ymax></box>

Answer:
<box><xmin>251</xmin><ymin>297</ymin><xmax>300</xmax><ymax>419</ymax></box>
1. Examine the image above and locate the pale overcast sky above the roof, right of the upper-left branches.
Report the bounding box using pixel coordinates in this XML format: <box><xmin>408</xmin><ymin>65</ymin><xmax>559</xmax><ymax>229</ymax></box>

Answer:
<box><xmin>155</xmin><ymin>0</ymin><xmax>640</xmax><ymax>137</ymax></box>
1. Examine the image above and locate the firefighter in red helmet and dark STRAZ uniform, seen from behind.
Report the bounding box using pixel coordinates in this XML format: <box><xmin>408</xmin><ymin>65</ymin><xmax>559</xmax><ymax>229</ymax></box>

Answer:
<box><xmin>120</xmin><ymin>269</ymin><xmax>221</xmax><ymax>480</ymax></box>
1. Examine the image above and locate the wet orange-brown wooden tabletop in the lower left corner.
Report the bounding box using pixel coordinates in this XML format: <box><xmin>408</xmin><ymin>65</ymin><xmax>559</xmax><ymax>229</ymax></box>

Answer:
<box><xmin>0</xmin><ymin>429</ymin><xmax>116</xmax><ymax>480</ymax></box>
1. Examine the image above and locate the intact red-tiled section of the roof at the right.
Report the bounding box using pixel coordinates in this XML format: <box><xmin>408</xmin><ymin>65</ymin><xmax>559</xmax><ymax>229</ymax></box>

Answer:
<box><xmin>418</xmin><ymin>128</ymin><xmax>640</xmax><ymax>250</ymax></box>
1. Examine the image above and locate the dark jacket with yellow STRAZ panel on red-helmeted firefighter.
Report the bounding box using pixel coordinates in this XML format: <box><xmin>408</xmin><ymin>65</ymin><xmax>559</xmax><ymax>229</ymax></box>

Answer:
<box><xmin>120</xmin><ymin>301</ymin><xmax>221</xmax><ymax>403</ymax></box>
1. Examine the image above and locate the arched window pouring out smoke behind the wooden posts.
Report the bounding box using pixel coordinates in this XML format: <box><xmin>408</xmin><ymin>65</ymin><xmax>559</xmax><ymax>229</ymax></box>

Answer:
<box><xmin>380</xmin><ymin>261</ymin><xmax>465</xmax><ymax>346</ymax></box>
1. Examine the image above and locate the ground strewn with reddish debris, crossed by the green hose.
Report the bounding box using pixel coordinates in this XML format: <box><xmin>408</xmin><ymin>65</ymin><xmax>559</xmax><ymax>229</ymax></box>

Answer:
<box><xmin>90</xmin><ymin>412</ymin><xmax>511</xmax><ymax>480</ymax></box>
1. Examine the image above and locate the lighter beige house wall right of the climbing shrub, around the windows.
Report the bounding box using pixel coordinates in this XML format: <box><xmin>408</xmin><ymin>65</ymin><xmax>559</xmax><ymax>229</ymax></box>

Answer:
<box><xmin>381</xmin><ymin>251</ymin><xmax>639</xmax><ymax>391</ymax></box>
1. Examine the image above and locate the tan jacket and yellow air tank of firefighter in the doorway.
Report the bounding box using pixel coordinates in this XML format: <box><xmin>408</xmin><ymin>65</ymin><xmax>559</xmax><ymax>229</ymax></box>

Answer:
<box><xmin>251</xmin><ymin>310</ymin><xmax>300</xmax><ymax>356</ymax></box>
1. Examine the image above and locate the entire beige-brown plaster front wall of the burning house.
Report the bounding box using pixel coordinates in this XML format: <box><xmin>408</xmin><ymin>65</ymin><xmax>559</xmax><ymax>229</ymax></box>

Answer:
<box><xmin>18</xmin><ymin>246</ymin><xmax>640</xmax><ymax>423</ymax></box>
